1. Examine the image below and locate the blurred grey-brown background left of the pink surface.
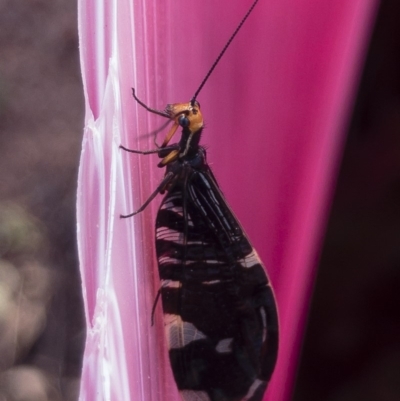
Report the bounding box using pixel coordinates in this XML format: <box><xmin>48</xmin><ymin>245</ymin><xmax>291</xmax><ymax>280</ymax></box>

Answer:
<box><xmin>0</xmin><ymin>0</ymin><xmax>85</xmax><ymax>401</ymax></box>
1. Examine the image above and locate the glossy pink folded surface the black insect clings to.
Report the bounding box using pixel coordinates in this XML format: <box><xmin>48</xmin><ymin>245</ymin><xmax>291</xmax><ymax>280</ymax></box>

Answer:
<box><xmin>78</xmin><ymin>0</ymin><xmax>376</xmax><ymax>401</ymax></box>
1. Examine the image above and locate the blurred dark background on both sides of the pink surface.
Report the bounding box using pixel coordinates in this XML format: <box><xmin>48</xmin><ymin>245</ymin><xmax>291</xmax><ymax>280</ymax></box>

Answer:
<box><xmin>0</xmin><ymin>0</ymin><xmax>400</xmax><ymax>401</ymax></box>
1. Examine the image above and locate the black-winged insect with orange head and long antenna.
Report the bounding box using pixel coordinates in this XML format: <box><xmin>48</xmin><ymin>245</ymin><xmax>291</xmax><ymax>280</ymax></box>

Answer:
<box><xmin>121</xmin><ymin>0</ymin><xmax>278</xmax><ymax>401</ymax></box>
